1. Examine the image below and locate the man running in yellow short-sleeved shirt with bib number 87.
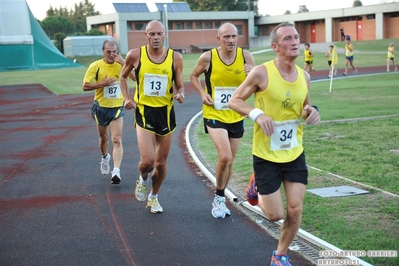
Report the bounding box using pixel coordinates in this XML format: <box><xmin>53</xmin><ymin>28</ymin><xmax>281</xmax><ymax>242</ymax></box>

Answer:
<box><xmin>82</xmin><ymin>40</ymin><xmax>133</xmax><ymax>184</ymax></box>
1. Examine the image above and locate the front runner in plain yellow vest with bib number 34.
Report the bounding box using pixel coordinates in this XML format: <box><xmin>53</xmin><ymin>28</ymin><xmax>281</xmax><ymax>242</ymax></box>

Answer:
<box><xmin>228</xmin><ymin>22</ymin><xmax>320</xmax><ymax>266</ymax></box>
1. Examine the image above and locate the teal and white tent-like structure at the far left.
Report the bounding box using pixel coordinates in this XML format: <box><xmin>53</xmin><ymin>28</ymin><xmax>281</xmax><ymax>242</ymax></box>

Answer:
<box><xmin>0</xmin><ymin>0</ymin><xmax>82</xmax><ymax>71</ymax></box>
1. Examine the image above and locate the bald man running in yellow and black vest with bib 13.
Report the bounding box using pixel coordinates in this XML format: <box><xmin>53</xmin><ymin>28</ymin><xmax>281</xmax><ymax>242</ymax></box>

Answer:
<box><xmin>121</xmin><ymin>20</ymin><xmax>184</xmax><ymax>213</ymax></box>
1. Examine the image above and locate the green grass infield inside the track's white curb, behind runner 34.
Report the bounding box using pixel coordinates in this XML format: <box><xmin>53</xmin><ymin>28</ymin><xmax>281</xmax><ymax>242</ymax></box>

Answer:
<box><xmin>197</xmin><ymin>73</ymin><xmax>399</xmax><ymax>265</ymax></box>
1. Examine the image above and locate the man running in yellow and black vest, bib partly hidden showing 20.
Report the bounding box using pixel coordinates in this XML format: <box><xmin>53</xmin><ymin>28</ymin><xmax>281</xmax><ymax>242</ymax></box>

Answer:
<box><xmin>190</xmin><ymin>23</ymin><xmax>255</xmax><ymax>218</ymax></box>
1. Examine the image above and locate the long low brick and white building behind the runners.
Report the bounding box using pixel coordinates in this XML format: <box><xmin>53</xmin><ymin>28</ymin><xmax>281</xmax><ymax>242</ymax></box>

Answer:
<box><xmin>86</xmin><ymin>2</ymin><xmax>399</xmax><ymax>53</ymax></box>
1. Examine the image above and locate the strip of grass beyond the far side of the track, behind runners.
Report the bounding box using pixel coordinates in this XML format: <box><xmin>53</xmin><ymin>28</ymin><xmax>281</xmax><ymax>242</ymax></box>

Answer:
<box><xmin>0</xmin><ymin>39</ymin><xmax>399</xmax><ymax>94</ymax></box>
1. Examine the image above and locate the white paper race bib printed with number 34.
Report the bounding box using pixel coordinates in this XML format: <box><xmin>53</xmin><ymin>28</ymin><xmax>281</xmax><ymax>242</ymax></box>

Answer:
<box><xmin>270</xmin><ymin>120</ymin><xmax>299</xmax><ymax>151</ymax></box>
